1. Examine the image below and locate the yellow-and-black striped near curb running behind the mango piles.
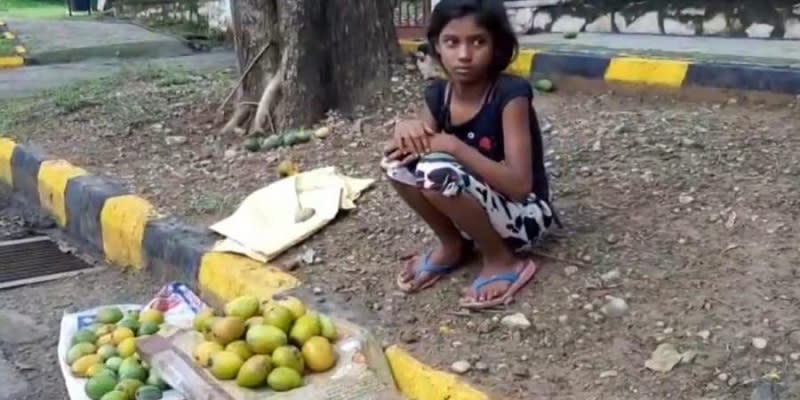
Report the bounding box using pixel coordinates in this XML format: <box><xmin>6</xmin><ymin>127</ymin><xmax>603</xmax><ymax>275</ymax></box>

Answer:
<box><xmin>0</xmin><ymin>137</ymin><xmax>491</xmax><ymax>400</ymax></box>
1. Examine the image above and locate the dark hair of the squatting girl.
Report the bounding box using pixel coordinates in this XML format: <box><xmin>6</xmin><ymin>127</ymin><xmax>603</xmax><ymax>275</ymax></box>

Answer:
<box><xmin>428</xmin><ymin>0</ymin><xmax>519</xmax><ymax>76</ymax></box>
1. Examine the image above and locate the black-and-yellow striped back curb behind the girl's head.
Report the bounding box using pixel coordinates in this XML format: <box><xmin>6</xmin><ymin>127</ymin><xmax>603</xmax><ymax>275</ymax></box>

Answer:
<box><xmin>400</xmin><ymin>40</ymin><xmax>800</xmax><ymax>94</ymax></box>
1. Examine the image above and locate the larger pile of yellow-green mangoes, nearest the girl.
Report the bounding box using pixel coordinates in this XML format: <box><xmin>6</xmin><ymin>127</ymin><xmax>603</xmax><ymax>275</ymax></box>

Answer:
<box><xmin>193</xmin><ymin>296</ymin><xmax>337</xmax><ymax>392</ymax></box>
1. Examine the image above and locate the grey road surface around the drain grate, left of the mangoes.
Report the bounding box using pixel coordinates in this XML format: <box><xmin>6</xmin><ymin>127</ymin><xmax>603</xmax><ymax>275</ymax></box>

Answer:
<box><xmin>0</xmin><ymin>188</ymin><xmax>168</xmax><ymax>400</ymax></box>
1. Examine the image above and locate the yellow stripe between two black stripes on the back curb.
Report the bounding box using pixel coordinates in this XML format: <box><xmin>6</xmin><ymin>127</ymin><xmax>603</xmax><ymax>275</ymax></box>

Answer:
<box><xmin>605</xmin><ymin>57</ymin><xmax>689</xmax><ymax>88</ymax></box>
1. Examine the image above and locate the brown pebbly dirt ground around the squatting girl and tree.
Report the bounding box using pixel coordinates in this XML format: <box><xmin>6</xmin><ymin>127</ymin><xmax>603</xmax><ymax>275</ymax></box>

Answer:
<box><xmin>1</xmin><ymin>61</ymin><xmax>800</xmax><ymax>399</ymax></box>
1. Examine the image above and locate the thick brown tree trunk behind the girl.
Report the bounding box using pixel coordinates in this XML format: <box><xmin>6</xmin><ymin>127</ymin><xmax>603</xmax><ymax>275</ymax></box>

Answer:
<box><xmin>226</xmin><ymin>0</ymin><xmax>399</xmax><ymax>133</ymax></box>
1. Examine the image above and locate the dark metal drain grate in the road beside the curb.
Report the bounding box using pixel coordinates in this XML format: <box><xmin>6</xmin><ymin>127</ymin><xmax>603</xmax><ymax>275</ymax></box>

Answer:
<box><xmin>0</xmin><ymin>236</ymin><xmax>95</xmax><ymax>289</ymax></box>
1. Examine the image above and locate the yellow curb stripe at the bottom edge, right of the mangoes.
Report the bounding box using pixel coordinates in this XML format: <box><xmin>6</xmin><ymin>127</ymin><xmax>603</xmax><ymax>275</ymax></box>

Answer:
<box><xmin>386</xmin><ymin>346</ymin><xmax>490</xmax><ymax>400</ymax></box>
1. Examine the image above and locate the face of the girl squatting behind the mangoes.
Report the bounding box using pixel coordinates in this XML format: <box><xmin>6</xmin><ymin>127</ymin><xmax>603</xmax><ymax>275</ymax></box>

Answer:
<box><xmin>436</xmin><ymin>15</ymin><xmax>492</xmax><ymax>83</ymax></box>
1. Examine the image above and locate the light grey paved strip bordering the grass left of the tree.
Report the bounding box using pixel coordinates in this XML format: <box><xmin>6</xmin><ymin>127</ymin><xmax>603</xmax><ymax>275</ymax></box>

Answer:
<box><xmin>0</xmin><ymin>51</ymin><xmax>236</xmax><ymax>99</ymax></box>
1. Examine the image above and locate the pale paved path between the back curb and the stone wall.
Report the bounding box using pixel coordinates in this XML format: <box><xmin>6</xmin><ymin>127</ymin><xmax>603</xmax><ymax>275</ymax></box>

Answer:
<box><xmin>520</xmin><ymin>33</ymin><xmax>800</xmax><ymax>68</ymax></box>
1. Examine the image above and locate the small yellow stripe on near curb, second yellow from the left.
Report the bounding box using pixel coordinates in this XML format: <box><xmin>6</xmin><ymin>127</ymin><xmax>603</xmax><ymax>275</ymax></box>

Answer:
<box><xmin>38</xmin><ymin>160</ymin><xmax>86</xmax><ymax>227</ymax></box>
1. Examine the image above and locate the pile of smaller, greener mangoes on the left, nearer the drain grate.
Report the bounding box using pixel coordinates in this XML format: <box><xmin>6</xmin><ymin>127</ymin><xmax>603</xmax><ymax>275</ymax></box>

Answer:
<box><xmin>66</xmin><ymin>307</ymin><xmax>169</xmax><ymax>400</ymax></box>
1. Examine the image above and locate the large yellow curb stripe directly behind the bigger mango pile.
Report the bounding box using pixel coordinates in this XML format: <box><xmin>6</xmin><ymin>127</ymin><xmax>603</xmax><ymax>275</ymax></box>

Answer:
<box><xmin>197</xmin><ymin>251</ymin><xmax>300</xmax><ymax>301</ymax></box>
